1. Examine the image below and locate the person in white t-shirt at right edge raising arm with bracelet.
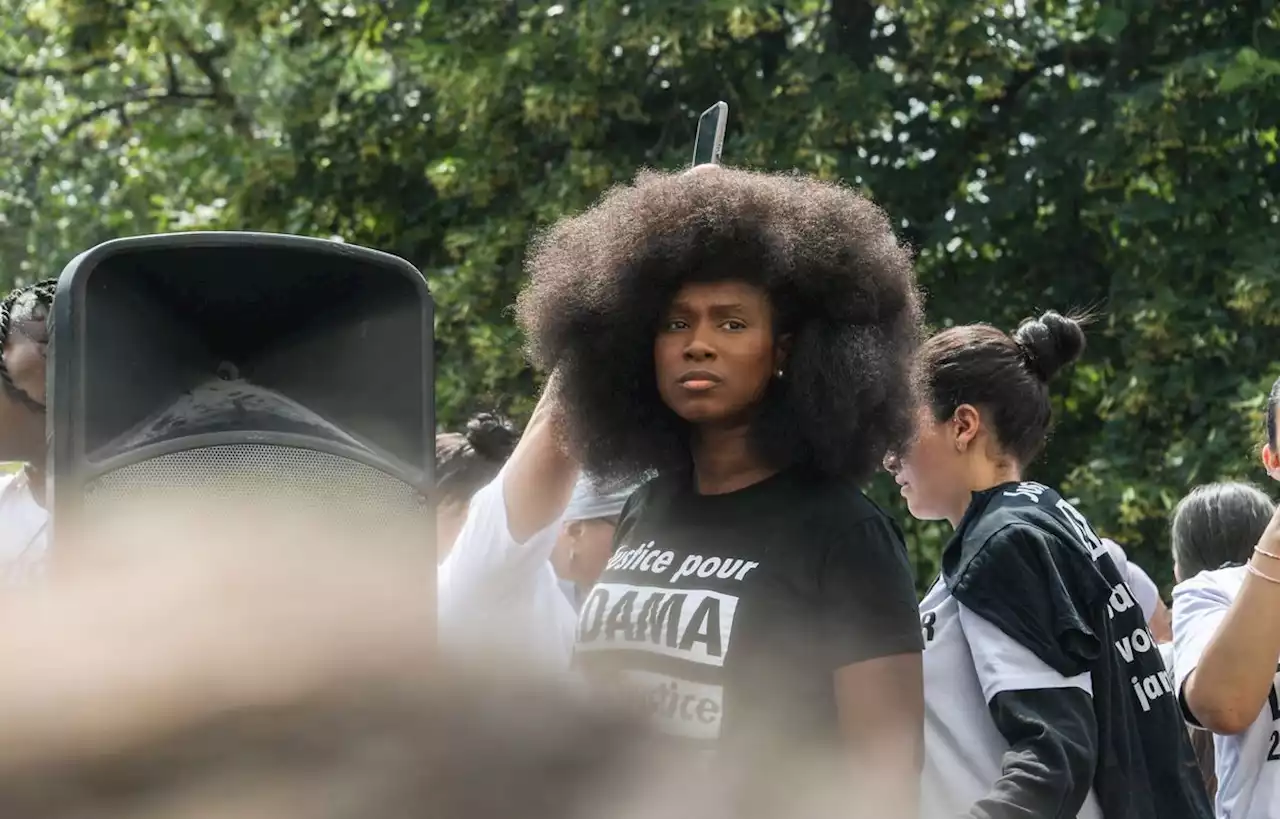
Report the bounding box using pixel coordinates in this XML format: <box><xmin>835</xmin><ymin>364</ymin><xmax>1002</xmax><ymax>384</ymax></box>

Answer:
<box><xmin>1174</xmin><ymin>380</ymin><xmax>1280</xmax><ymax>819</ymax></box>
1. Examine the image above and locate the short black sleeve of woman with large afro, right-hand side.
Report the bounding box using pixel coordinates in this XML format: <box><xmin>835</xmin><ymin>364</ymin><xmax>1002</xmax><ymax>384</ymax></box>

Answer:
<box><xmin>819</xmin><ymin>514</ymin><xmax>924</xmax><ymax>669</ymax></box>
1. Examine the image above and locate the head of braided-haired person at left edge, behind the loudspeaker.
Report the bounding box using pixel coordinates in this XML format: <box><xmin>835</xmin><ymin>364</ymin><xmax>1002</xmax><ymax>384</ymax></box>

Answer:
<box><xmin>0</xmin><ymin>280</ymin><xmax>58</xmax><ymax>463</ymax></box>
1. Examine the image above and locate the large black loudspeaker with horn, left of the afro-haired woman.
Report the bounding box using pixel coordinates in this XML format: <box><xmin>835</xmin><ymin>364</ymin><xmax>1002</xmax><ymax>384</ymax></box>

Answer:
<box><xmin>49</xmin><ymin>233</ymin><xmax>435</xmax><ymax>554</ymax></box>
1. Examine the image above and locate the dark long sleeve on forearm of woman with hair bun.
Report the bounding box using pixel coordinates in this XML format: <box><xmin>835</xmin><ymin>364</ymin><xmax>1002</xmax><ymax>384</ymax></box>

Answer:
<box><xmin>965</xmin><ymin>688</ymin><xmax>1098</xmax><ymax>819</ymax></box>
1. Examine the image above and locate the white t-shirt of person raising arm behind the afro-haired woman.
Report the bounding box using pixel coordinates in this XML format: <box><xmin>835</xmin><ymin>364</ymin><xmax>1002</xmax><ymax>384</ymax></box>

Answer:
<box><xmin>438</xmin><ymin>468</ymin><xmax>577</xmax><ymax>673</ymax></box>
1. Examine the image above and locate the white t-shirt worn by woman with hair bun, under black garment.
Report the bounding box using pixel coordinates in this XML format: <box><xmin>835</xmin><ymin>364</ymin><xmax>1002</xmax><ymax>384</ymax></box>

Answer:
<box><xmin>920</xmin><ymin>578</ymin><xmax>1102</xmax><ymax>819</ymax></box>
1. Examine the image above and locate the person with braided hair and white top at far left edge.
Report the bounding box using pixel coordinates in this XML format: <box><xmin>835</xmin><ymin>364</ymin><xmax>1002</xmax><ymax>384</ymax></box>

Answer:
<box><xmin>0</xmin><ymin>280</ymin><xmax>58</xmax><ymax>584</ymax></box>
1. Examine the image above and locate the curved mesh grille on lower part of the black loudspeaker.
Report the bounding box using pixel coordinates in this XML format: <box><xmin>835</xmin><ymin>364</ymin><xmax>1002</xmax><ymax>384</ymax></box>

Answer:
<box><xmin>84</xmin><ymin>444</ymin><xmax>429</xmax><ymax>521</ymax></box>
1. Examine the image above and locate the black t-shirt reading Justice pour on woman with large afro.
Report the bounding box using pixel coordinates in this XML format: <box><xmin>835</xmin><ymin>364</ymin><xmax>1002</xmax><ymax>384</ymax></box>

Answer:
<box><xmin>575</xmin><ymin>470</ymin><xmax>923</xmax><ymax>759</ymax></box>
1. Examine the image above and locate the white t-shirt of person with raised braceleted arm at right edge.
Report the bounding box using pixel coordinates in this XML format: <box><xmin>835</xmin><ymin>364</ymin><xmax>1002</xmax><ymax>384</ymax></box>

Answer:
<box><xmin>1174</xmin><ymin>566</ymin><xmax>1280</xmax><ymax>819</ymax></box>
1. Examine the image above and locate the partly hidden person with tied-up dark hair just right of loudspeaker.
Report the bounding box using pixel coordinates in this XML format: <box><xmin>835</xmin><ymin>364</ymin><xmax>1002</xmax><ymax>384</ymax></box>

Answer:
<box><xmin>435</xmin><ymin>412</ymin><xmax>520</xmax><ymax>561</ymax></box>
